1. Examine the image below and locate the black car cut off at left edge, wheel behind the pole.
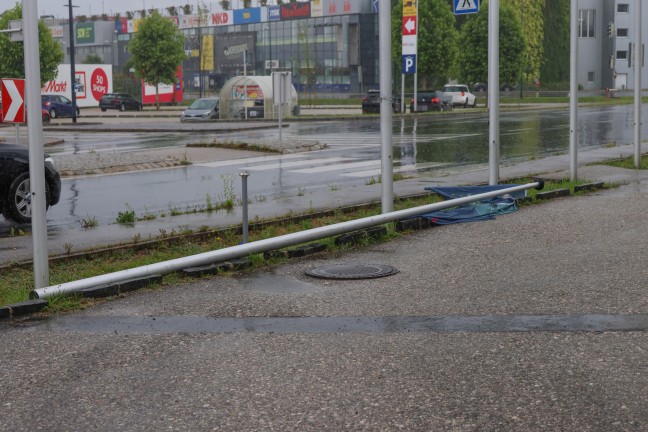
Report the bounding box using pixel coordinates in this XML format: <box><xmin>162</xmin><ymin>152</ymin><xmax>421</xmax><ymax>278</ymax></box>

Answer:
<box><xmin>0</xmin><ymin>144</ymin><xmax>61</xmax><ymax>223</ymax></box>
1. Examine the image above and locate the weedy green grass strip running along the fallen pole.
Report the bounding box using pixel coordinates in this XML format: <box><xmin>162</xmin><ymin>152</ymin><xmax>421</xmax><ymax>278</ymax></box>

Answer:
<box><xmin>0</xmin><ymin>178</ymin><xmax>612</xmax><ymax>312</ymax></box>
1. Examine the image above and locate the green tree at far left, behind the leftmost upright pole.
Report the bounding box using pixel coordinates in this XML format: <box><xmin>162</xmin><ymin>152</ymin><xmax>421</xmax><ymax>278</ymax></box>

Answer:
<box><xmin>0</xmin><ymin>5</ymin><xmax>63</xmax><ymax>86</ymax></box>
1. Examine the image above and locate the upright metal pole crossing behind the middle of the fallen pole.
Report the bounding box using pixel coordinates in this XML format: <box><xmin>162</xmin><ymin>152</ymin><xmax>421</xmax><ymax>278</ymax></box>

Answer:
<box><xmin>378</xmin><ymin>1</ymin><xmax>394</xmax><ymax>213</ymax></box>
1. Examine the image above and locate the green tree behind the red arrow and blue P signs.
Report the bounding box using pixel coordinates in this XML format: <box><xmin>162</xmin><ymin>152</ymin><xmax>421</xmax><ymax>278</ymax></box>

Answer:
<box><xmin>392</xmin><ymin>0</ymin><xmax>458</xmax><ymax>88</ymax></box>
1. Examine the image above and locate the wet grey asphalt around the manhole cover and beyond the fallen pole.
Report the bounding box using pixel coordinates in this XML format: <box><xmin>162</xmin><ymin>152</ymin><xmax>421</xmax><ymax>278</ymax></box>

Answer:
<box><xmin>0</xmin><ymin>110</ymin><xmax>648</xmax><ymax>431</ymax></box>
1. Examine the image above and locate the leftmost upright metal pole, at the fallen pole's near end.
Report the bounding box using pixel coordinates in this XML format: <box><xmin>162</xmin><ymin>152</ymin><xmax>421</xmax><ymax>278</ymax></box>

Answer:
<box><xmin>22</xmin><ymin>0</ymin><xmax>49</xmax><ymax>288</ymax></box>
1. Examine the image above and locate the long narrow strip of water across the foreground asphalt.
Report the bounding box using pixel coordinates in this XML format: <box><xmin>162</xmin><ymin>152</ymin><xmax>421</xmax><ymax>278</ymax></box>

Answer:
<box><xmin>25</xmin><ymin>314</ymin><xmax>648</xmax><ymax>334</ymax></box>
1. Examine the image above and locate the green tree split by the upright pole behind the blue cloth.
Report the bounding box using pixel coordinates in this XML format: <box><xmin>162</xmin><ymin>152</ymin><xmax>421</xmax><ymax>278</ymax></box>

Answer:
<box><xmin>457</xmin><ymin>1</ymin><xmax>526</xmax><ymax>88</ymax></box>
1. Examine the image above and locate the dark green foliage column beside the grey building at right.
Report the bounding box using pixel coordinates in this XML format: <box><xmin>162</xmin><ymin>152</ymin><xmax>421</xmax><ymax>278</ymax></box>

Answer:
<box><xmin>540</xmin><ymin>0</ymin><xmax>570</xmax><ymax>83</ymax></box>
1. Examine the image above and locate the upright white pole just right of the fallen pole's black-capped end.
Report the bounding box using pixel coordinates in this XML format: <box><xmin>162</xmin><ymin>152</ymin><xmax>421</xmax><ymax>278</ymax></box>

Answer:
<box><xmin>569</xmin><ymin>0</ymin><xmax>578</xmax><ymax>181</ymax></box>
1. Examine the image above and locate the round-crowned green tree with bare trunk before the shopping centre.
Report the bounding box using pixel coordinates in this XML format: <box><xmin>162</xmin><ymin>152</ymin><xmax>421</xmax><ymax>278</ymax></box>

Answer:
<box><xmin>128</xmin><ymin>11</ymin><xmax>185</xmax><ymax>110</ymax></box>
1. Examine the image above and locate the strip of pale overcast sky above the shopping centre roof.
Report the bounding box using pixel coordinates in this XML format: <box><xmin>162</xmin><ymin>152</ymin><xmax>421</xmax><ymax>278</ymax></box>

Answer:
<box><xmin>0</xmin><ymin>0</ymin><xmax>274</xmax><ymax>18</ymax></box>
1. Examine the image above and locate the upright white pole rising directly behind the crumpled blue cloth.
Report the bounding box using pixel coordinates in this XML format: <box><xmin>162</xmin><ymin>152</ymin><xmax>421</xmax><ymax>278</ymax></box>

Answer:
<box><xmin>488</xmin><ymin>0</ymin><xmax>500</xmax><ymax>185</ymax></box>
